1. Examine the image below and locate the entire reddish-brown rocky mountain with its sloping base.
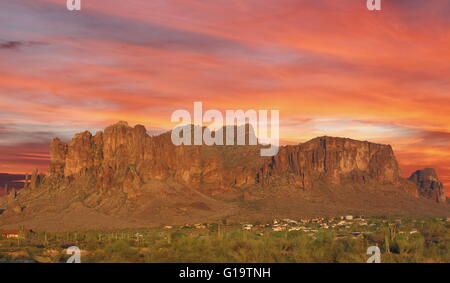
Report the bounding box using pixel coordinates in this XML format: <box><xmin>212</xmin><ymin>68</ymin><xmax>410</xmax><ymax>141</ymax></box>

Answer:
<box><xmin>0</xmin><ymin>122</ymin><xmax>450</xmax><ymax>231</ymax></box>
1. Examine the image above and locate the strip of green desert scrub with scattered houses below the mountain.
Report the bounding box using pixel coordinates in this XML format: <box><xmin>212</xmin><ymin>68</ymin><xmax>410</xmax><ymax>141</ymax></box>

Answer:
<box><xmin>0</xmin><ymin>217</ymin><xmax>450</xmax><ymax>263</ymax></box>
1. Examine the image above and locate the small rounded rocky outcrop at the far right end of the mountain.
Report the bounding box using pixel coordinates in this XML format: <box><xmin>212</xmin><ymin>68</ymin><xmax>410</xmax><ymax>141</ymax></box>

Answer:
<box><xmin>408</xmin><ymin>168</ymin><xmax>446</xmax><ymax>202</ymax></box>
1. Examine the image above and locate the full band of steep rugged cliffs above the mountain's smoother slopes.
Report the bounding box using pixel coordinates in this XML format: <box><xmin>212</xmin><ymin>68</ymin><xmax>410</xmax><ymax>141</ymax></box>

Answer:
<box><xmin>44</xmin><ymin>122</ymin><xmax>417</xmax><ymax>197</ymax></box>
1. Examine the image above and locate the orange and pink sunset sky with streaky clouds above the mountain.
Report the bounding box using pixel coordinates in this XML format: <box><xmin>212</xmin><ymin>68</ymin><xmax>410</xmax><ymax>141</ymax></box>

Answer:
<box><xmin>0</xmin><ymin>0</ymin><xmax>450</xmax><ymax>195</ymax></box>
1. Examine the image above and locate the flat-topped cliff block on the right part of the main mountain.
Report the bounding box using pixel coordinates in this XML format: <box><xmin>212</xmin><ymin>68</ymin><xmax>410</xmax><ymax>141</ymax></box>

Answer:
<box><xmin>261</xmin><ymin>137</ymin><xmax>401</xmax><ymax>189</ymax></box>
